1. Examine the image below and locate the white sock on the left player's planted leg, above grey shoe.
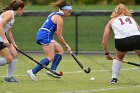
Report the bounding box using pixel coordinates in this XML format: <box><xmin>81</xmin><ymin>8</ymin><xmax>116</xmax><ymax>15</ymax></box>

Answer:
<box><xmin>6</xmin><ymin>59</ymin><xmax>17</xmax><ymax>77</ymax></box>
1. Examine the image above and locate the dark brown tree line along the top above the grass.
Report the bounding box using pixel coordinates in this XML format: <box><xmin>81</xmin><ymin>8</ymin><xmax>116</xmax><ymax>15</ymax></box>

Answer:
<box><xmin>23</xmin><ymin>0</ymin><xmax>140</xmax><ymax>5</ymax></box>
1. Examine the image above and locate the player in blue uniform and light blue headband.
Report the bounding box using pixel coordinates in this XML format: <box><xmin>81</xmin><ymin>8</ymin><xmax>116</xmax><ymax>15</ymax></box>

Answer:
<box><xmin>27</xmin><ymin>0</ymin><xmax>72</xmax><ymax>81</ymax></box>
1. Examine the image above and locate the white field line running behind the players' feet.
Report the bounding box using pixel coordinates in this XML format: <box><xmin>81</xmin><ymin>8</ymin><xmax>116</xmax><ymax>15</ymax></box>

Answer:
<box><xmin>0</xmin><ymin>68</ymin><xmax>140</xmax><ymax>77</ymax></box>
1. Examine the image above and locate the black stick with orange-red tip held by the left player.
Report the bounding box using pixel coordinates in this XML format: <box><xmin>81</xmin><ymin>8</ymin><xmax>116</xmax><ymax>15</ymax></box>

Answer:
<box><xmin>15</xmin><ymin>47</ymin><xmax>63</xmax><ymax>76</ymax></box>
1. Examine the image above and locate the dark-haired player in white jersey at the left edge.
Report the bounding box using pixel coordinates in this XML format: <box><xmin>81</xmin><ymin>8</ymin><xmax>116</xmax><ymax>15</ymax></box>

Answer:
<box><xmin>0</xmin><ymin>0</ymin><xmax>25</xmax><ymax>82</ymax></box>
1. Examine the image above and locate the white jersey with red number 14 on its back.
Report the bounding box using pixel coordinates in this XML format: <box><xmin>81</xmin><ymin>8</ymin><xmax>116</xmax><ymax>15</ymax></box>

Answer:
<box><xmin>111</xmin><ymin>16</ymin><xmax>140</xmax><ymax>39</ymax></box>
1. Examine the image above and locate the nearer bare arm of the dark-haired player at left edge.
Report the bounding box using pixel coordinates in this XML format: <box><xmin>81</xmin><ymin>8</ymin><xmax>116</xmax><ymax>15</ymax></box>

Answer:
<box><xmin>0</xmin><ymin>11</ymin><xmax>12</xmax><ymax>46</ymax></box>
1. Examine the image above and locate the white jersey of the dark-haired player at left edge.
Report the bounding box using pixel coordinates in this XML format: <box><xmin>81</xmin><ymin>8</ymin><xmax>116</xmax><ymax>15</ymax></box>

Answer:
<box><xmin>0</xmin><ymin>10</ymin><xmax>15</xmax><ymax>41</ymax></box>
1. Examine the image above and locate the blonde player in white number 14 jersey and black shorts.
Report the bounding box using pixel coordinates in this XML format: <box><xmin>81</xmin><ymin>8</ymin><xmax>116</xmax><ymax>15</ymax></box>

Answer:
<box><xmin>102</xmin><ymin>4</ymin><xmax>140</xmax><ymax>84</ymax></box>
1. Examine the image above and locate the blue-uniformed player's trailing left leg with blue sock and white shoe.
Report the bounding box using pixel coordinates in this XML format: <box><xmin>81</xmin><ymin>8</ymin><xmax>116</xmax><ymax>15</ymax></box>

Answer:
<box><xmin>27</xmin><ymin>43</ymin><xmax>54</xmax><ymax>80</ymax></box>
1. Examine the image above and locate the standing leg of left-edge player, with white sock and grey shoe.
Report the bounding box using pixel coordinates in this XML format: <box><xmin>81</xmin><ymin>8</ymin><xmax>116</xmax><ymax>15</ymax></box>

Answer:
<box><xmin>4</xmin><ymin>44</ymin><xmax>20</xmax><ymax>82</ymax></box>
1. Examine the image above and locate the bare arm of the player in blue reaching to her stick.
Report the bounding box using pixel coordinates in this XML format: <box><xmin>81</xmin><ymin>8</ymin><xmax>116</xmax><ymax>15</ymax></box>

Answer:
<box><xmin>52</xmin><ymin>15</ymin><xmax>71</xmax><ymax>51</ymax></box>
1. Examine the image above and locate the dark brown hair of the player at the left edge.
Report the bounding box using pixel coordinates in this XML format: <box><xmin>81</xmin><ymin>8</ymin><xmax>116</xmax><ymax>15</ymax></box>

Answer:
<box><xmin>3</xmin><ymin>0</ymin><xmax>25</xmax><ymax>11</ymax></box>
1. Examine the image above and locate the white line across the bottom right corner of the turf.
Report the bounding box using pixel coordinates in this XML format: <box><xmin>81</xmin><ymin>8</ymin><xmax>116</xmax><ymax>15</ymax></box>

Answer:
<box><xmin>61</xmin><ymin>85</ymin><xmax>140</xmax><ymax>93</ymax></box>
